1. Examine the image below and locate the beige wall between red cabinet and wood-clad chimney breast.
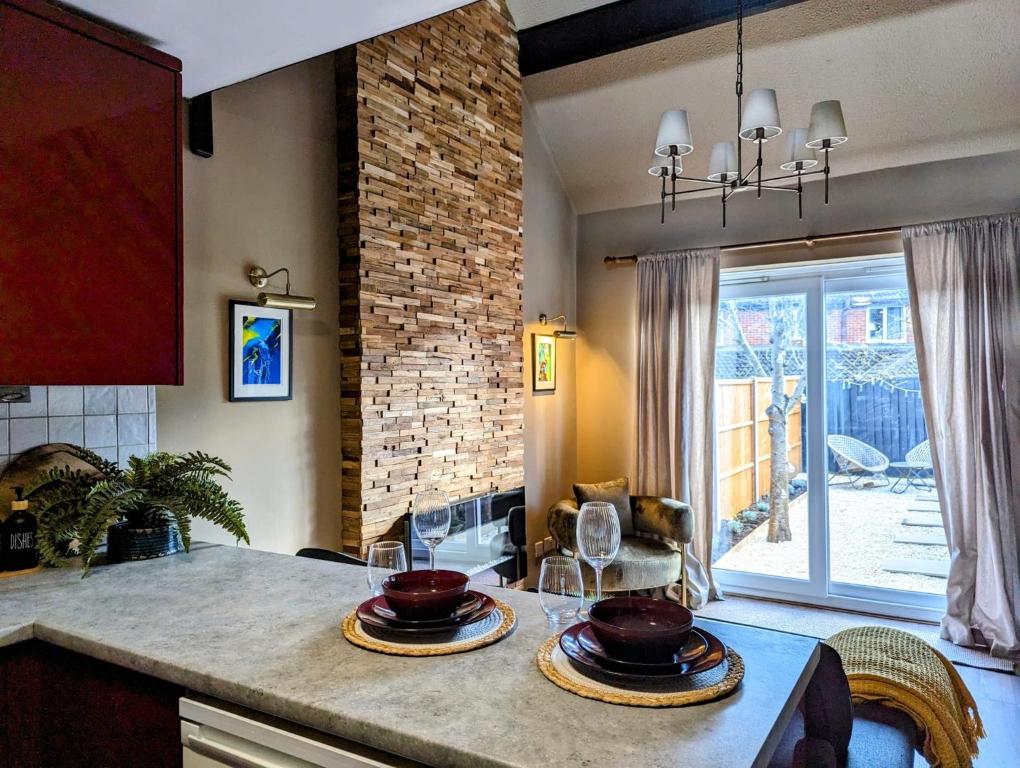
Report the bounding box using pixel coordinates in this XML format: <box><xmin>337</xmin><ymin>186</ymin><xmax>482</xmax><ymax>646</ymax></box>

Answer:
<box><xmin>157</xmin><ymin>55</ymin><xmax>340</xmax><ymax>553</ymax></box>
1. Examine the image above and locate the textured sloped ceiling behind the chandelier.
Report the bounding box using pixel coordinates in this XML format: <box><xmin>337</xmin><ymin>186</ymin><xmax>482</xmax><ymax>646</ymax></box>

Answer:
<box><xmin>524</xmin><ymin>0</ymin><xmax>1020</xmax><ymax>213</ymax></box>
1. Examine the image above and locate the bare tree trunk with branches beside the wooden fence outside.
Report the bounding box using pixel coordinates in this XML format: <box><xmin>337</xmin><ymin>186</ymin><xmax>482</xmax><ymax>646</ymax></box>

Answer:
<box><xmin>723</xmin><ymin>298</ymin><xmax>807</xmax><ymax>543</ymax></box>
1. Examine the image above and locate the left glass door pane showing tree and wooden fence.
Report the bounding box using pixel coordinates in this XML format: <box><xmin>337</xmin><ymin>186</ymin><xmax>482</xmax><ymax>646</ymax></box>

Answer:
<box><xmin>712</xmin><ymin>294</ymin><xmax>808</xmax><ymax>579</ymax></box>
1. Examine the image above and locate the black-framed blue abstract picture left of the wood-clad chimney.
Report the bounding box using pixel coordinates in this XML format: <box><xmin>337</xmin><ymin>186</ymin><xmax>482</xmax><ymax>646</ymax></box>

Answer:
<box><xmin>230</xmin><ymin>301</ymin><xmax>294</xmax><ymax>402</ymax></box>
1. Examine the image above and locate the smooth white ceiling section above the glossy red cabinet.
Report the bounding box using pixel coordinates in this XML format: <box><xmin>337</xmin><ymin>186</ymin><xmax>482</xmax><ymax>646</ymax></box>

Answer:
<box><xmin>60</xmin><ymin>0</ymin><xmax>467</xmax><ymax>97</ymax></box>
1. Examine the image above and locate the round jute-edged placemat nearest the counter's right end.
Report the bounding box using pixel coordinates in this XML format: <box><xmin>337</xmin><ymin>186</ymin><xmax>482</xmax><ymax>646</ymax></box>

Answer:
<box><xmin>537</xmin><ymin>634</ymin><xmax>744</xmax><ymax>707</ymax></box>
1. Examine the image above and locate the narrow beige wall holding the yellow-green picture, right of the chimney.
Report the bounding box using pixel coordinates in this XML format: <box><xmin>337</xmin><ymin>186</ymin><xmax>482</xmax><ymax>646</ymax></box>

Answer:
<box><xmin>524</xmin><ymin>102</ymin><xmax>578</xmax><ymax>558</ymax></box>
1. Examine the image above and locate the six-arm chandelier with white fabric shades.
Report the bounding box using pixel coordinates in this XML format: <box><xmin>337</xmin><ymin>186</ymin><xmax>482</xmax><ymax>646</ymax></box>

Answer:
<box><xmin>648</xmin><ymin>0</ymin><xmax>847</xmax><ymax>226</ymax></box>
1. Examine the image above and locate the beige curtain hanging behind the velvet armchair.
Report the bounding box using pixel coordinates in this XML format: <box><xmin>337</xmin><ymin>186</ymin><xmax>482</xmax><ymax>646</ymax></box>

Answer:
<box><xmin>638</xmin><ymin>248</ymin><xmax>721</xmax><ymax>608</ymax></box>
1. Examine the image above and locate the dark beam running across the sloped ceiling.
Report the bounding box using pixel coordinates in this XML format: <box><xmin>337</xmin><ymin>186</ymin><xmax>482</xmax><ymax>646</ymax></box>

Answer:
<box><xmin>517</xmin><ymin>0</ymin><xmax>804</xmax><ymax>75</ymax></box>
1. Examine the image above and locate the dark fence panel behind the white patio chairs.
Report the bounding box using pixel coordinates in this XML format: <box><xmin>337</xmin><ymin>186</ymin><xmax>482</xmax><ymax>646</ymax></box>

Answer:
<box><xmin>825</xmin><ymin>378</ymin><xmax>928</xmax><ymax>471</ymax></box>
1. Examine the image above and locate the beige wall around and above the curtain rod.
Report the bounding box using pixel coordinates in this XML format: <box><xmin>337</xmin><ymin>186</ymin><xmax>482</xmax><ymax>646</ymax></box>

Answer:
<box><xmin>577</xmin><ymin>152</ymin><xmax>1020</xmax><ymax>491</ymax></box>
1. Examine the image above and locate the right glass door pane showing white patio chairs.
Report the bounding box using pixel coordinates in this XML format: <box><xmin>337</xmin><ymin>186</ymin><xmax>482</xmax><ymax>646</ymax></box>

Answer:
<box><xmin>825</xmin><ymin>281</ymin><xmax>949</xmax><ymax>594</ymax></box>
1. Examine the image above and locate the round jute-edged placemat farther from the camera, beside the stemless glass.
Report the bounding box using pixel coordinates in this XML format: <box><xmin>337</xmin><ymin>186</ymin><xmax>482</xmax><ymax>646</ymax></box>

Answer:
<box><xmin>340</xmin><ymin>598</ymin><xmax>517</xmax><ymax>656</ymax></box>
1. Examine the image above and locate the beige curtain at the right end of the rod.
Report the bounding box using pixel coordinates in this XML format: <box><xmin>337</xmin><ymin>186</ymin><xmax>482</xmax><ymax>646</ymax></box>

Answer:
<box><xmin>903</xmin><ymin>214</ymin><xmax>1020</xmax><ymax>655</ymax></box>
